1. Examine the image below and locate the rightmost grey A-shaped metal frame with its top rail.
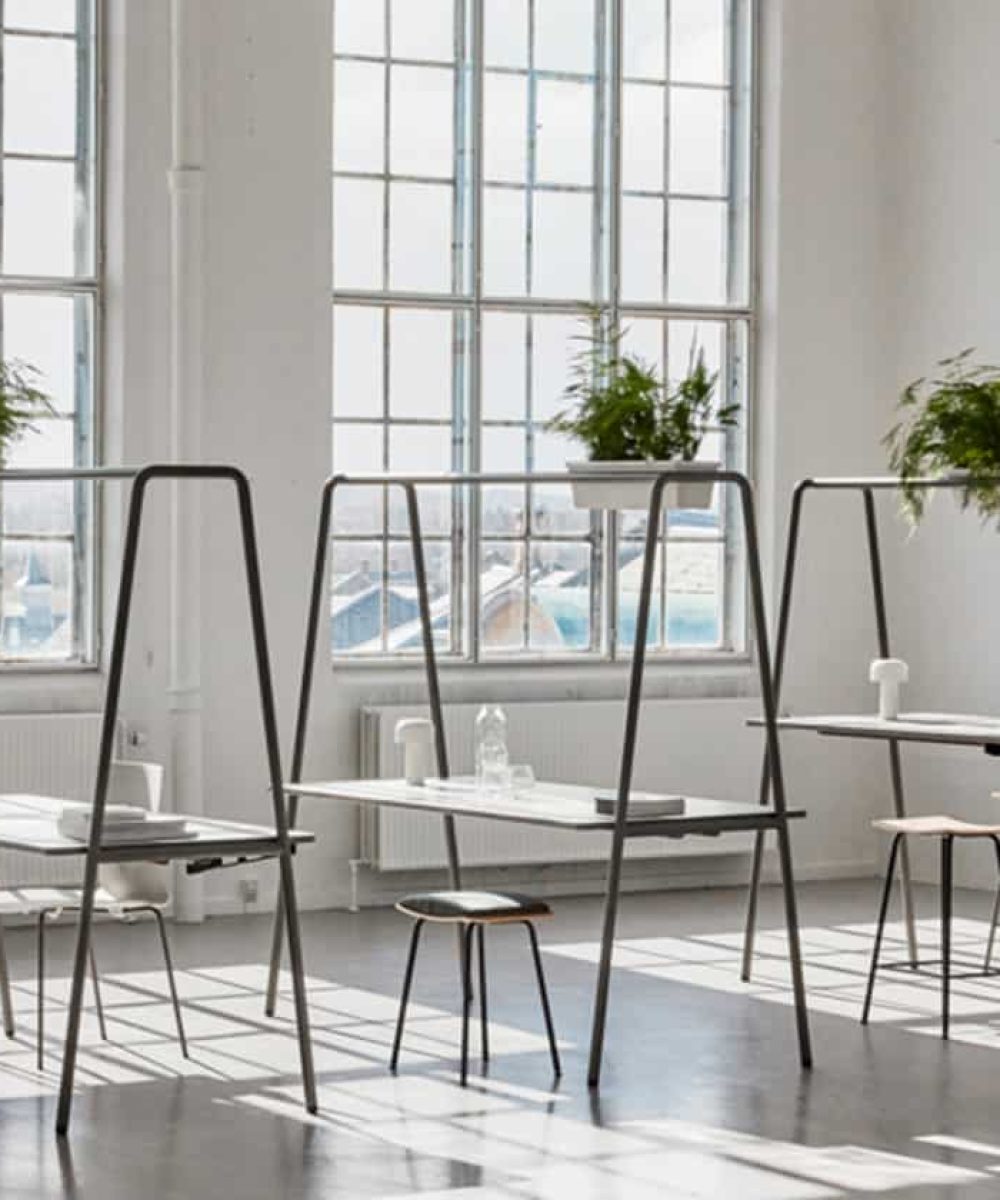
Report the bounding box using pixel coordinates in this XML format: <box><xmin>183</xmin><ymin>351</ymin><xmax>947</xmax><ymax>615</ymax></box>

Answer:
<box><xmin>741</xmin><ymin>475</ymin><xmax>993</xmax><ymax>982</ymax></box>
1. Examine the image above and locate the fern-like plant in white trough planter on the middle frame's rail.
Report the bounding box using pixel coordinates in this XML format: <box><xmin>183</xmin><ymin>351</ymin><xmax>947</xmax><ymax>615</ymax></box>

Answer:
<box><xmin>546</xmin><ymin>312</ymin><xmax>738</xmax><ymax>509</ymax></box>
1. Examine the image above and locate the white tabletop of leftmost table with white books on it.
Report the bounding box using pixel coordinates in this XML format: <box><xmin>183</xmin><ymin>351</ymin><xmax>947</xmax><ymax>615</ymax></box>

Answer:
<box><xmin>0</xmin><ymin>793</ymin><xmax>313</xmax><ymax>860</ymax></box>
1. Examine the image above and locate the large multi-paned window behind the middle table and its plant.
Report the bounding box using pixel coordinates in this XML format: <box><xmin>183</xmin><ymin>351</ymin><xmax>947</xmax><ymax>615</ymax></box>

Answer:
<box><xmin>330</xmin><ymin>0</ymin><xmax>753</xmax><ymax>661</ymax></box>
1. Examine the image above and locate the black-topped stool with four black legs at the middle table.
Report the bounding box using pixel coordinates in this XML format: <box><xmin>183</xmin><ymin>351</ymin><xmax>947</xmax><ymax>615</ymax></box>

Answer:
<box><xmin>389</xmin><ymin>892</ymin><xmax>562</xmax><ymax>1087</ymax></box>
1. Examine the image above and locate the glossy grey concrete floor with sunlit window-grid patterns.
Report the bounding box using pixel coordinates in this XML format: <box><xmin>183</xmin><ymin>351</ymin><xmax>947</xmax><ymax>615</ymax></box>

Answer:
<box><xmin>0</xmin><ymin>881</ymin><xmax>1000</xmax><ymax>1200</ymax></box>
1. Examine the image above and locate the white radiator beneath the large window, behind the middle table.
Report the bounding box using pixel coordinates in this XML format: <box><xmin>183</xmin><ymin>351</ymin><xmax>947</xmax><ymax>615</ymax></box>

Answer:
<box><xmin>360</xmin><ymin>700</ymin><xmax>761</xmax><ymax>871</ymax></box>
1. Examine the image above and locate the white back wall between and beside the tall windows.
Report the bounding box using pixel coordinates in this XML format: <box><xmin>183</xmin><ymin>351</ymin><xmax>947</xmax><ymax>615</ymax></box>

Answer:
<box><xmin>5</xmin><ymin>0</ymin><xmax>892</xmax><ymax>908</ymax></box>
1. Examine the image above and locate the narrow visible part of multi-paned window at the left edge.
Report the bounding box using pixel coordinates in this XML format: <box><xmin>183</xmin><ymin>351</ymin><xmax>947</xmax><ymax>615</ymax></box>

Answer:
<box><xmin>0</xmin><ymin>0</ymin><xmax>98</xmax><ymax>665</ymax></box>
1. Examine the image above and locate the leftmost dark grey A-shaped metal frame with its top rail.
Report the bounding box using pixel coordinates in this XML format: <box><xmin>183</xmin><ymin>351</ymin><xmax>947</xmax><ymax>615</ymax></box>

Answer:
<box><xmin>0</xmin><ymin>463</ymin><xmax>317</xmax><ymax>1135</ymax></box>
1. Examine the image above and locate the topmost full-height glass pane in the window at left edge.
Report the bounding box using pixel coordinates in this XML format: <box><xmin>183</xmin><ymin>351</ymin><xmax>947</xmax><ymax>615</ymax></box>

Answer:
<box><xmin>4</xmin><ymin>37</ymin><xmax>77</xmax><ymax>156</ymax></box>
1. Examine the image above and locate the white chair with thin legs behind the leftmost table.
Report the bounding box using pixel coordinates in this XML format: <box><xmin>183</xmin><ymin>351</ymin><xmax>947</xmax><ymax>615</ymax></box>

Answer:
<box><xmin>0</xmin><ymin>761</ymin><xmax>188</xmax><ymax>1070</ymax></box>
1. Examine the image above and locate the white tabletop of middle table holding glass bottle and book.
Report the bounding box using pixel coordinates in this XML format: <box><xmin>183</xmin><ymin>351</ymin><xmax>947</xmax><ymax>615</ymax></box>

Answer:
<box><xmin>285</xmin><ymin>779</ymin><xmax>803</xmax><ymax>838</ymax></box>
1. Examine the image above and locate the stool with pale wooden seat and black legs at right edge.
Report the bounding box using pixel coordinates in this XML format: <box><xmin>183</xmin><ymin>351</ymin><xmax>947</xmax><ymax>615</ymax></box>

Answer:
<box><xmin>861</xmin><ymin>816</ymin><xmax>1000</xmax><ymax>1038</ymax></box>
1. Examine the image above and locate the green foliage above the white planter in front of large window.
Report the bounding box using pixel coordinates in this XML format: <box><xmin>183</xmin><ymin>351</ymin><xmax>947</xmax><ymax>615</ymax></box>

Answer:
<box><xmin>545</xmin><ymin>310</ymin><xmax>738</xmax><ymax>462</ymax></box>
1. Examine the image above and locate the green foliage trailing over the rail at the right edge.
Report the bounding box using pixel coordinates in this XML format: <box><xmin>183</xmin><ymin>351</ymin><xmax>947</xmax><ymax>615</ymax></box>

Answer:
<box><xmin>882</xmin><ymin>348</ymin><xmax>1000</xmax><ymax>524</ymax></box>
